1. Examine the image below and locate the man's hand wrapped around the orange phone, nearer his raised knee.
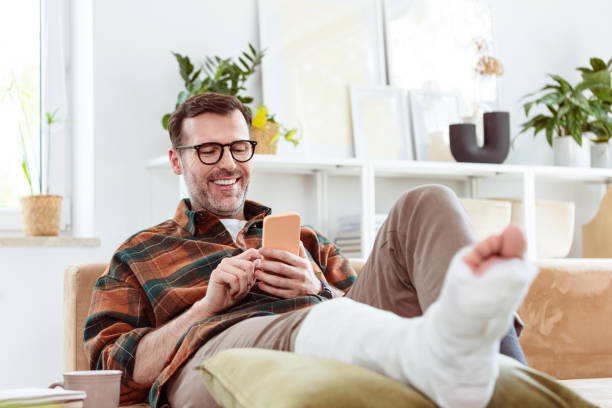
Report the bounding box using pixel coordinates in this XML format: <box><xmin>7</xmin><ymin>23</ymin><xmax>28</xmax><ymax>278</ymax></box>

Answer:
<box><xmin>255</xmin><ymin>241</ymin><xmax>321</xmax><ymax>299</ymax></box>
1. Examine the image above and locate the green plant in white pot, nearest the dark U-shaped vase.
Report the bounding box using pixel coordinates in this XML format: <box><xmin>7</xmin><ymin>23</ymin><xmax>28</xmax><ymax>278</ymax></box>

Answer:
<box><xmin>521</xmin><ymin>75</ymin><xmax>592</xmax><ymax>167</ymax></box>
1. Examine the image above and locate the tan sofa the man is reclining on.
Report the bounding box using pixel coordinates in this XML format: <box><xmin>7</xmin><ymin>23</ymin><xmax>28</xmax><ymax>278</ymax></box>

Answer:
<box><xmin>63</xmin><ymin>260</ymin><xmax>612</xmax><ymax>407</ymax></box>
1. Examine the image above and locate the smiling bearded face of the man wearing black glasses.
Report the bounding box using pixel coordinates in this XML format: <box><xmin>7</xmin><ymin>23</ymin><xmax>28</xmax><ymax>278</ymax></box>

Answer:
<box><xmin>170</xmin><ymin>110</ymin><xmax>251</xmax><ymax>219</ymax></box>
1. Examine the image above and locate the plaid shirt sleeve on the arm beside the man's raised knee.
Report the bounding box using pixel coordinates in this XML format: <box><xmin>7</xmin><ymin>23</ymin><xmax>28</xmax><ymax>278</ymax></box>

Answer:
<box><xmin>300</xmin><ymin>227</ymin><xmax>357</xmax><ymax>293</ymax></box>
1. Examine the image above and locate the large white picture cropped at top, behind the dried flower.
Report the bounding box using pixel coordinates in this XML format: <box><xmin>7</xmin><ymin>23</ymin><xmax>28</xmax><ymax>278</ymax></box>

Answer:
<box><xmin>383</xmin><ymin>0</ymin><xmax>499</xmax><ymax>117</ymax></box>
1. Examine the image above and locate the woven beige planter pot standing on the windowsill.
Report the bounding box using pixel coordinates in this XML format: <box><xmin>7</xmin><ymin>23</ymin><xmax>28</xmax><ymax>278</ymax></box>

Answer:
<box><xmin>21</xmin><ymin>195</ymin><xmax>62</xmax><ymax>236</ymax></box>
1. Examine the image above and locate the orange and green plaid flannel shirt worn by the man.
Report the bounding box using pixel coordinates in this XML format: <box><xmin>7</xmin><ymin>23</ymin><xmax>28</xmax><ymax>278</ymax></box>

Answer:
<box><xmin>83</xmin><ymin>199</ymin><xmax>356</xmax><ymax>407</ymax></box>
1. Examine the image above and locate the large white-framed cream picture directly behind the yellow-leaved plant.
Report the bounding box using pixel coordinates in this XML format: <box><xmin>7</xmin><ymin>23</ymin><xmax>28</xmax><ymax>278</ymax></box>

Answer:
<box><xmin>258</xmin><ymin>0</ymin><xmax>386</xmax><ymax>158</ymax></box>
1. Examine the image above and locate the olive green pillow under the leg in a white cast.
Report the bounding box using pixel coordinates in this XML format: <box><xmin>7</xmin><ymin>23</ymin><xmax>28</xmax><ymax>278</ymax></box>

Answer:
<box><xmin>198</xmin><ymin>348</ymin><xmax>595</xmax><ymax>408</ymax></box>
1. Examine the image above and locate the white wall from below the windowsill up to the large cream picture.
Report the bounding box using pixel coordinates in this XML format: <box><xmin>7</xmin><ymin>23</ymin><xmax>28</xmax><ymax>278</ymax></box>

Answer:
<box><xmin>0</xmin><ymin>0</ymin><xmax>261</xmax><ymax>389</ymax></box>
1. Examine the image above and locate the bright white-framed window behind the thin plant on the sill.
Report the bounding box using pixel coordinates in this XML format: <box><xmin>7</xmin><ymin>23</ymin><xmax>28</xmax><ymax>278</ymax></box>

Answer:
<box><xmin>0</xmin><ymin>0</ymin><xmax>71</xmax><ymax>231</ymax></box>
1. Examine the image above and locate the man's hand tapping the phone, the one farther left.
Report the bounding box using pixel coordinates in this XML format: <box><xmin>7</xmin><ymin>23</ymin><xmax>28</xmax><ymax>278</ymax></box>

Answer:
<box><xmin>193</xmin><ymin>248</ymin><xmax>262</xmax><ymax>316</ymax></box>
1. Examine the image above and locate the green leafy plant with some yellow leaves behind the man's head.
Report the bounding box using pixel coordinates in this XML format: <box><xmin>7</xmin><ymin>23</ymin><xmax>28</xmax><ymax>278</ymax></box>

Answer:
<box><xmin>162</xmin><ymin>44</ymin><xmax>299</xmax><ymax>145</ymax></box>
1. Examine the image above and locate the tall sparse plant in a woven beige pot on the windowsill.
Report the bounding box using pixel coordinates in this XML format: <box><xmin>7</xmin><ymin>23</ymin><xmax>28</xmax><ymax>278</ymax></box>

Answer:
<box><xmin>5</xmin><ymin>78</ymin><xmax>62</xmax><ymax>236</ymax></box>
